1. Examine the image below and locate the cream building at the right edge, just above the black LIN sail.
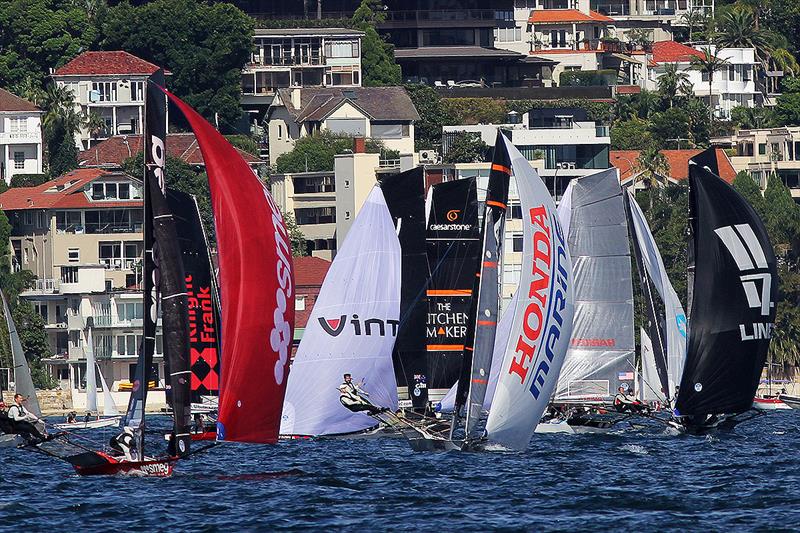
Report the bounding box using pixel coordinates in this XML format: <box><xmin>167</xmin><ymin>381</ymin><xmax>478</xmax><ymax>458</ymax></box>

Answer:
<box><xmin>711</xmin><ymin>126</ymin><xmax>800</xmax><ymax>202</ymax></box>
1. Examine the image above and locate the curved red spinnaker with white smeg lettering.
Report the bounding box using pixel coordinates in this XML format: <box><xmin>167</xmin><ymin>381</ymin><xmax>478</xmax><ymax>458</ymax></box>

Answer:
<box><xmin>165</xmin><ymin>91</ymin><xmax>294</xmax><ymax>443</ymax></box>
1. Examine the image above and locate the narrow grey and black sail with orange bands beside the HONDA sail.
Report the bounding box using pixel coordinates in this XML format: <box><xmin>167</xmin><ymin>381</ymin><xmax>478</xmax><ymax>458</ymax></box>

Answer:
<box><xmin>451</xmin><ymin>130</ymin><xmax>511</xmax><ymax>440</ymax></box>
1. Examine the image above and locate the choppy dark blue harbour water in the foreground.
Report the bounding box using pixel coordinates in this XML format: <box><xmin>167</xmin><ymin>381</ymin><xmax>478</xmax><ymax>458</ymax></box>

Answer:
<box><xmin>0</xmin><ymin>411</ymin><xmax>800</xmax><ymax>532</ymax></box>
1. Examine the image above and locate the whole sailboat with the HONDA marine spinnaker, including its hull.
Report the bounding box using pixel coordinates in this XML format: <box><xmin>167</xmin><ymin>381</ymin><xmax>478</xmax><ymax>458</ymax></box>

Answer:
<box><xmin>403</xmin><ymin>132</ymin><xmax>573</xmax><ymax>451</ymax></box>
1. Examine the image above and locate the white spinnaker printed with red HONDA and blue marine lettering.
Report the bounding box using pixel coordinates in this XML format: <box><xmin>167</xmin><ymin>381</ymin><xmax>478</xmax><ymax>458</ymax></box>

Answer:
<box><xmin>486</xmin><ymin>138</ymin><xmax>574</xmax><ymax>450</ymax></box>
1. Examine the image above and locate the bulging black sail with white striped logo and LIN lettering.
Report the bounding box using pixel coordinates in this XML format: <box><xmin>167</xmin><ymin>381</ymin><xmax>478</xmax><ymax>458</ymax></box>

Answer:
<box><xmin>676</xmin><ymin>153</ymin><xmax>778</xmax><ymax>415</ymax></box>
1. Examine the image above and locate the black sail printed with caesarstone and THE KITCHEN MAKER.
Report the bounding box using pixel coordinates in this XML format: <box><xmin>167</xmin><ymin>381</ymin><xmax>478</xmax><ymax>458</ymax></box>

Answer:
<box><xmin>427</xmin><ymin>178</ymin><xmax>481</xmax><ymax>392</ymax></box>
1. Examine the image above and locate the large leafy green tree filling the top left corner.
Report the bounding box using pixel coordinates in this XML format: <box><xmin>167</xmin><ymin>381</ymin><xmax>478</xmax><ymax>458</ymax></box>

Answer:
<box><xmin>0</xmin><ymin>0</ymin><xmax>98</xmax><ymax>87</ymax></box>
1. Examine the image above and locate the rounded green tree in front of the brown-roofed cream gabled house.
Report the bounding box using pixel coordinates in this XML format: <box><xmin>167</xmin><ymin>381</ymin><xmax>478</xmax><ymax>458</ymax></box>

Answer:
<box><xmin>275</xmin><ymin>130</ymin><xmax>384</xmax><ymax>174</ymax></box>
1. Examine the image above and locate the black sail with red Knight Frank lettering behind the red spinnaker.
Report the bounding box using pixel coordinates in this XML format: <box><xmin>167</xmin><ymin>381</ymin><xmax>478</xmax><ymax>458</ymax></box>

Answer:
<box><xmin>167</xmin><ymin>189</ymin><xmax>222</xmax><ymax>403</ymax></box>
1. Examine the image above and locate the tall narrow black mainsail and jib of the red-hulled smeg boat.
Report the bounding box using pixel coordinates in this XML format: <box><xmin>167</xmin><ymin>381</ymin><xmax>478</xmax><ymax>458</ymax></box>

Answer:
<box><xmin>143</xmin><ymin>74</ymin><xmax>191</xmax><ymax>456</ymax></box>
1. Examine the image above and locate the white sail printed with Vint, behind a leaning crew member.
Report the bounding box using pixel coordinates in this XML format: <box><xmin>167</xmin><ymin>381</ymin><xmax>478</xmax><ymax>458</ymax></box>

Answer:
<box><xmin>280</xmin><ymin>186</ymin><xmax>401</xmax><ymax>435</ymax></box>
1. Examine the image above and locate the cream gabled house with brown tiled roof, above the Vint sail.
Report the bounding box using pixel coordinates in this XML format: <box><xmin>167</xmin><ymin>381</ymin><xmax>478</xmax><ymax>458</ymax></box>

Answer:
<box><xmin>265</xmin><ymin>87</ymin><xmax>419</xmax><ymax>164</ymax></box>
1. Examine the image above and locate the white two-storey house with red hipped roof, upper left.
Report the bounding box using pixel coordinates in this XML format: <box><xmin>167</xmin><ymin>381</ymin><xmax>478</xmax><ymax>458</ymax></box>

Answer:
<box><xmin>52</xmin><ymin>51</ymin><xmax>169</xmax><ymax>149</ymax></box>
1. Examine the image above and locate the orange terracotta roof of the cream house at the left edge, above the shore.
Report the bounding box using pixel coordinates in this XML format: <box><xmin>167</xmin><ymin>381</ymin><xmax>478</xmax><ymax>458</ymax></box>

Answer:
<box><xmin>0</xmin><ymin>168</ymin><xmax>143</xmax><ymax>211</ymax></box>
